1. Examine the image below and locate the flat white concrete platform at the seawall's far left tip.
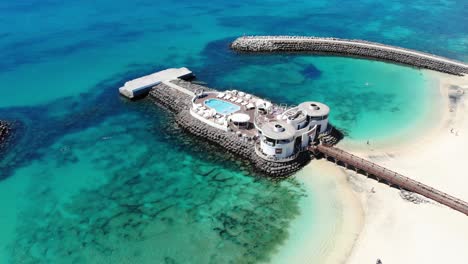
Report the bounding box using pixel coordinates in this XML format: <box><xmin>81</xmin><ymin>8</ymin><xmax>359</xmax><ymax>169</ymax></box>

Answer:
<box><xmin>119</xmin><ymin>67</ymin><xmax>193</xmax><ymax>98</ymax></box>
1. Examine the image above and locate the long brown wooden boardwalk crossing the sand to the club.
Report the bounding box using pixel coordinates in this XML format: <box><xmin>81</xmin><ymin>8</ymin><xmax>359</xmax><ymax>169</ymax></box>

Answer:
<box><xmin>312</xmin><ymin>144</ymin><xmax>468</xmax><ymax>215</ymax></box>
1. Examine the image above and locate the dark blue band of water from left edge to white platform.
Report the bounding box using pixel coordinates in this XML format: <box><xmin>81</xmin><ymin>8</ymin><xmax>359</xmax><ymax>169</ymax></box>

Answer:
<box><xmin>0</xmin><ymin>65</ymin><xmax>168</xmax><ymax>180</ymax></box>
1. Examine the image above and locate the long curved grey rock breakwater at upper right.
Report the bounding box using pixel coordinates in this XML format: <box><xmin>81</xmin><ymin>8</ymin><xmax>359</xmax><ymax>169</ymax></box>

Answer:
<box><xmin>231</xmin><ymin>36</ymin><xmax>468</xmax><ymax>76</ymax></box>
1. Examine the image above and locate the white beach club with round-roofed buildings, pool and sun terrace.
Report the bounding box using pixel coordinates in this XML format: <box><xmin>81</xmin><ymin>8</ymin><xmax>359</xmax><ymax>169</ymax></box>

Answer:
<box><xmin>190</xmin><ymin>86</ymin><xmax>330</xmax><ymax>162</ymax></box>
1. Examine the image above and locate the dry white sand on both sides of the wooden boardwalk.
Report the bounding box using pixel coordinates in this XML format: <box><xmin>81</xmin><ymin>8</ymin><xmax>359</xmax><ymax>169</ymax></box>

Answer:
<box><xmin>340</xmin><ymin>72</ymin><xmax>468</xmax><ymax>264</ymax></box>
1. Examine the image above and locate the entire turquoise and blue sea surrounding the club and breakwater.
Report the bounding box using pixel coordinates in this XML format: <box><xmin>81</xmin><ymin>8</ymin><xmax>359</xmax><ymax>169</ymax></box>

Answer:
<box><xmin>0</xmin><ymin>0</ymin><xmax>468</xmax><ymax>263</ymax></box>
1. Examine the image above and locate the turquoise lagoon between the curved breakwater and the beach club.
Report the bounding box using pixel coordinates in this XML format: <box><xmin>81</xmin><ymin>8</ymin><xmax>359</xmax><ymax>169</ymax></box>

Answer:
<box><xmin>220</xmin><ymin>56</ymin><xmax>434</xmax><ymax>141</ymax></box>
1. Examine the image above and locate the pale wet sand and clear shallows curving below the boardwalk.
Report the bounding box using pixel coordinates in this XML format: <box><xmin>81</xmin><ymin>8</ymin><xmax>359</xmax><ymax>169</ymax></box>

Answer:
<box><xmin>272</xmin><ymin>160</ymin><xmax>363</xmax><ymax>264</ymax></box>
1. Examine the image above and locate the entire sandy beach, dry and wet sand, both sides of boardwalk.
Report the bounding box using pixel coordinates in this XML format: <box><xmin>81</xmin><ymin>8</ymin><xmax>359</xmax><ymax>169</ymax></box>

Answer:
<box><xmin>274</xmin><ymin>71</ymin><xmax>468</xmax><ymax>264</ymax></box>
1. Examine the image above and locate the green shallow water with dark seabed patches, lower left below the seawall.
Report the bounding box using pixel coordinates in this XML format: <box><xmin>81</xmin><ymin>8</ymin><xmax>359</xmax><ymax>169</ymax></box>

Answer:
<box><xmin>0</xmin><ymin>108</ymin><xmax>306</xmax><ymax>263</ymax></box>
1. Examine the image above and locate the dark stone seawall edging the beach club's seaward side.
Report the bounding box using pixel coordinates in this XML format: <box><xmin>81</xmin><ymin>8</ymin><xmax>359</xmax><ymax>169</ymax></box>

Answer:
<box><xmin>149</xmin><ymin>80</ymin><xmax>311</xmax><ymax>177</ymax></box>
